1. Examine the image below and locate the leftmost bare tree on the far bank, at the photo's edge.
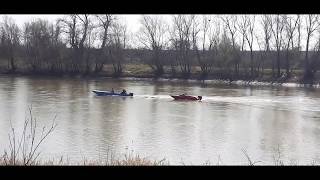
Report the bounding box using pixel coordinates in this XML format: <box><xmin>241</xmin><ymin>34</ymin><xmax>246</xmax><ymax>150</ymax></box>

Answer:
<box><xmin>1</xmin><ymin>16</ymin><xmax>20</xmax><ymax>72</ymax></box>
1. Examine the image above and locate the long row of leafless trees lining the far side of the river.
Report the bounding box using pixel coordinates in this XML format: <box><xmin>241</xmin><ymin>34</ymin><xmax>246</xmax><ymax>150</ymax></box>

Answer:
<box><xmin>0</xmin><ymin>14</ymin><xmax>320</xmax><ymax>82</ymax></box>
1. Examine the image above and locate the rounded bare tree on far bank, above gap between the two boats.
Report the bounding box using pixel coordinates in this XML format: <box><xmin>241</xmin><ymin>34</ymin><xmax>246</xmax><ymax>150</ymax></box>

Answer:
<box><xmin>138</xmin><ymin>15</ymin><xmax>168</xmax><ymax>76</ymax></box>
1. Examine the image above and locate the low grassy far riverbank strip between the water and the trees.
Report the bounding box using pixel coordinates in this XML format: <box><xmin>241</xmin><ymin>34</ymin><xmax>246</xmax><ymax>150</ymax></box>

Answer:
<box><xmin>0</xmin><ymin>64</ymin><xmax>320</xmax><ymax>88</ymax></box>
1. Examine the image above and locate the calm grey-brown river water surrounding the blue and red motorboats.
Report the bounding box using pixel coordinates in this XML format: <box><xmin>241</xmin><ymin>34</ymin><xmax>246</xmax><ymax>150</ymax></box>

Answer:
<box><xmin>0</xmin><ymin>76</ymin><xmax>320</xmax><ymax>164</ymax></box>
